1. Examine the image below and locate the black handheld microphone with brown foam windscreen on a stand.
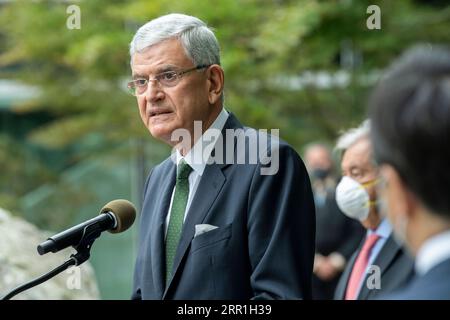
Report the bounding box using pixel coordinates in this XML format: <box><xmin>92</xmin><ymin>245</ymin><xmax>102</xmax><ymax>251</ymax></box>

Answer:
<box><xmin>37</xmin><ymin>199</ymin><xmax>136</xmax><ymax>255</ymax></box>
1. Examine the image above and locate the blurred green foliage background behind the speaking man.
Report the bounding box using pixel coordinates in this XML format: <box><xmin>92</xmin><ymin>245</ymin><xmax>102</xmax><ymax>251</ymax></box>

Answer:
<box><xmin>0</xmin><ymin>0</ymin><xmax>450</xmax><ymax>299</ymax></box>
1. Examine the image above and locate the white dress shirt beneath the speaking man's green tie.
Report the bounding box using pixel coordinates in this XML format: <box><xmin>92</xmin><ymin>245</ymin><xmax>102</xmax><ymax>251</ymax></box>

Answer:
<box><xmin>165</xmin><ymin>109</ymin><xmax>228</xmax><ymax>234</ymax></box>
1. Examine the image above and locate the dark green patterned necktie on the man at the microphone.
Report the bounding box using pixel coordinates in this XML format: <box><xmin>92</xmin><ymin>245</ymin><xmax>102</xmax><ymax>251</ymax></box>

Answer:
<box><xmin>166</xmin><ymin>159</ymin><xmax>192</xmax><ymax>285</ymax></box>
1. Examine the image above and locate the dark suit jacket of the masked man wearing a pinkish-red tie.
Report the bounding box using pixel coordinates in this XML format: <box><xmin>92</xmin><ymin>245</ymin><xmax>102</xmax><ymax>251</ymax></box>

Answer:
<box><xmin>334</xmin><ymin>234</ymin><xmax>414</xmax><ymax>300</ymax></box>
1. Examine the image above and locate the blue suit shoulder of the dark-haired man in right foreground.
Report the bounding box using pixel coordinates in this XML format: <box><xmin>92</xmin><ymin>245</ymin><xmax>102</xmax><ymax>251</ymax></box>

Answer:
<box><xmin>380</xmin><ymin>259</ymin><xmax>450</xmax><ymax>300</ymax></box>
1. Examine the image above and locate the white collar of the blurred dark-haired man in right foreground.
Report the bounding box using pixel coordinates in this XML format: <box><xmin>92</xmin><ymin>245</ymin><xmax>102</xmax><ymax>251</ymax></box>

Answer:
<box><xmin>415</xmin><ymin>230</ymin><xmax>450</xmax><ymax>274</ymax></box>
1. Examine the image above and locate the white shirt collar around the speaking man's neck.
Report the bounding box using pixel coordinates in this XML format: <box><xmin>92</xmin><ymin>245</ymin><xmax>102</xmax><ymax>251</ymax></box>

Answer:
<box><xmin>176</xmin><ymin>108</ymin><xmax>229</xmax><ymax>176</ymax></box>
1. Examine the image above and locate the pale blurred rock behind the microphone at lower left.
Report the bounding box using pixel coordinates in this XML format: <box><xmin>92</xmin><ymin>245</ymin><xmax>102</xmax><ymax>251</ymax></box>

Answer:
<box><xmin>0</xmin><ymin>208</ymin><xmax>99</xmax><ymax>300</ymax></box>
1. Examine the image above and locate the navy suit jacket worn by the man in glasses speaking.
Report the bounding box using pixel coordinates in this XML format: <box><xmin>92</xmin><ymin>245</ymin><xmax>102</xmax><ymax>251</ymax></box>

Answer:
<box><xmin>132</xmin><ymin>114</ymin><xmax>315</xmax><ymax>299</ymax></box>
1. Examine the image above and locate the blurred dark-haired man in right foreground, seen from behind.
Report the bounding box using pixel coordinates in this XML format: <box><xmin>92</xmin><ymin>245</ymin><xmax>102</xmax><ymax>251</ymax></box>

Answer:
<box><xmin>370</xmin><ymin>45</ymin><xmax>450</xmax><ymax>300</ymax></box>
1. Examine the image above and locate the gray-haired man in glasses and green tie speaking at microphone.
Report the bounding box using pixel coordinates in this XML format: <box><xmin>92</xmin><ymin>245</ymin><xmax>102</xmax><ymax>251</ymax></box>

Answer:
<box><xmin>128</xmin><ymin>14</ymin><xmax>315</xmax><ymax>299</ymax></box>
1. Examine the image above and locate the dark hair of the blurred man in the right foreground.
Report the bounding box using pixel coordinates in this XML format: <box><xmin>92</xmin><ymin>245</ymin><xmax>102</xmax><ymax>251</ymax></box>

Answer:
<box><xmin>369</xmin><ymin>45</ymin><xmax>450</xmax><ymax>219</ymax></box>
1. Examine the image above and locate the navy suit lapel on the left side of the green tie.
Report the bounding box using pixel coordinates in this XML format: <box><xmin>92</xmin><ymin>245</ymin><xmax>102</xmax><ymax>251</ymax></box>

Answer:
<box><xmin>150</xmin><ymin>162</ymin><xmax>176</xmax><ymax>297</ymax></box>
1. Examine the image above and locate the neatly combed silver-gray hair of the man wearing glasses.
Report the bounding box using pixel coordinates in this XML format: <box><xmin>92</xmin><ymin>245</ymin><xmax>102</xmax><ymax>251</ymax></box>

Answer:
<box><xmin>130</xmin><ymin>13</ymin><xmax>220</xmax><ymax>66</ymax></box>
